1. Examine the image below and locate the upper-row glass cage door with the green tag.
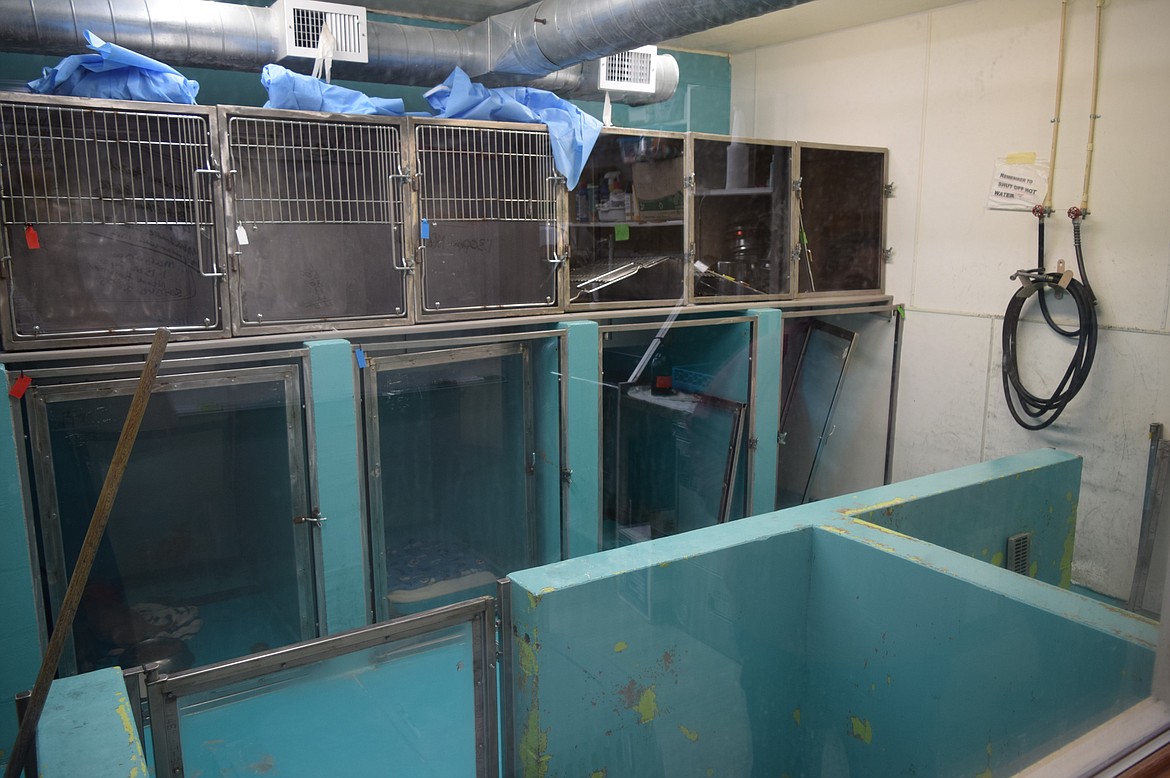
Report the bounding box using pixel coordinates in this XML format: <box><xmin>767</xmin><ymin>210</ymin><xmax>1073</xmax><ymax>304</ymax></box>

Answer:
<box><xmin>569</xmin><ymin>130</ymin><xmax>687</xmax><ymax>307</ymax></box>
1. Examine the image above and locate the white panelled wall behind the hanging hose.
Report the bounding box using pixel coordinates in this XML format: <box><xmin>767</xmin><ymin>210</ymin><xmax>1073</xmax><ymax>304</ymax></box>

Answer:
<box><xmin>731</xmin><ymin>0</ymin><xmax>1170</xmax><ymax>597</ymax></box>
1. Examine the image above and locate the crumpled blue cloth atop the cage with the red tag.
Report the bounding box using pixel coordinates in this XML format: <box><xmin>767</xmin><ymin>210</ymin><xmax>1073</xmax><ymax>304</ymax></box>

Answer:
<box><xmin>28</xmin><ymin>29</ymin><xmax>199</xmax><ymax>105</ymax></box>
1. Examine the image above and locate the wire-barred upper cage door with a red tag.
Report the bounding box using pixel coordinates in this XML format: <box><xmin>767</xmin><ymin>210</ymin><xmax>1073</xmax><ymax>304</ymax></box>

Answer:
<box><xmin>0</xmin><ymin>102</ymin><xmax>221</xmax><ymax>346</ymax></box>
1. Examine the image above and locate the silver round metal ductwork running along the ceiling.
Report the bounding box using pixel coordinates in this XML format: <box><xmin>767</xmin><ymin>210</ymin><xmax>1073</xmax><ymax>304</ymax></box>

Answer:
<box><xmin>0</xmin><ymin>0</ymin><xmax>808</xmax><ymax>104</ymax></box>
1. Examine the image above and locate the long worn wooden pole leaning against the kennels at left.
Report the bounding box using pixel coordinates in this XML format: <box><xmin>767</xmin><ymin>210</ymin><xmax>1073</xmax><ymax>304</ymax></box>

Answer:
<box><xmin>4</xmin><ymin>328</ymin><xmax>170</xmax><ymax>778</ymax></box>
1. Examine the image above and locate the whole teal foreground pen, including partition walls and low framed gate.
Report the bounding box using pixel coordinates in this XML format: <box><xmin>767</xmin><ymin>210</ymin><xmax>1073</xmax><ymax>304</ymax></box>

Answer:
<box><xmin>32</xmin><ymin>450</ymin><xmax>1156</xmax><ymax>778</ymax></box>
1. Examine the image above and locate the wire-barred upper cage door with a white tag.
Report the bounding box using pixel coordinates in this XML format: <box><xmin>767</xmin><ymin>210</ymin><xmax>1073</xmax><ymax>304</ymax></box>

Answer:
<box><xmin>227</xmin><ymin>116</ymin><xmax>406</xmax><ymax>325</ymax></box>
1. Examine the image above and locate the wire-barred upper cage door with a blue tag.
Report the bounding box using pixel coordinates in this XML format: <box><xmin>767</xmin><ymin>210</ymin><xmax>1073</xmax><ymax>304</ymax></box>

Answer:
<box><xmin>415</xmin><ymin>124</ymin><xmax>560</xmax><ymax>312</ymax></box>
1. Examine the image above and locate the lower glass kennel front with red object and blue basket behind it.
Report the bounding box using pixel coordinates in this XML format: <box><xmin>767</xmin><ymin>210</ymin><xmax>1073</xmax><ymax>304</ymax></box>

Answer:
<box><xmin>601</xmin><ymin>322</ymin><xmax>752</xmax><ymax>549</ymax></box>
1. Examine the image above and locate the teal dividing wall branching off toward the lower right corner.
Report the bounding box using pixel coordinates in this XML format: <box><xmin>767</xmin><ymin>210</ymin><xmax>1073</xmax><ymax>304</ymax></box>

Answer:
<box><xmin>792</xmin><ymin>525</ymin><xmax>1156</xmax><ymax>776</ymax></box>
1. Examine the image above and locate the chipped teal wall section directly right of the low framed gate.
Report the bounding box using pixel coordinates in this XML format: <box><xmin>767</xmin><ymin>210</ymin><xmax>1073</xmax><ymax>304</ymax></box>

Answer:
<box><xmin>505</xmin><ymin>530</ymin><xmax>812</xmax><ymax>778</ymax></box>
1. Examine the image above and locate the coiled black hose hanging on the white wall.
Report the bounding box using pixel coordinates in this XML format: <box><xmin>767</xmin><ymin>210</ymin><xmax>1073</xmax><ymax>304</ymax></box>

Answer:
<box><xmin>1003</xmin><ymin>218</ymin><xmax>1097</xmax><ymax>429</ymax></box>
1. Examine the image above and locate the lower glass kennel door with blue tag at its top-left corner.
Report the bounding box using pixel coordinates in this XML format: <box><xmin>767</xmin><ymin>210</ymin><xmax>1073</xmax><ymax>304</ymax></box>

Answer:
<box><xmin>365</xmin><ymin>343</ymin><xmax>559</xmax><ymax>618</ymax></box>
